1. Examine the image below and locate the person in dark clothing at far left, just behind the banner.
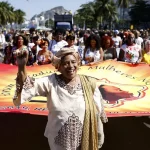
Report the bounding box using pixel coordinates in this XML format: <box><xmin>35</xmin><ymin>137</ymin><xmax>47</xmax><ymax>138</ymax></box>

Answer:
<box><xmin>3</xmin><ymin>44</ymin><xmax>13</xmax><ymax>65</ymax></box>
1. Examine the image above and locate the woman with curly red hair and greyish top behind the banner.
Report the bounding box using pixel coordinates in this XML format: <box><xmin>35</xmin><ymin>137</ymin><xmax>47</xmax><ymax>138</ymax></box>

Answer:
<box><xmin>101</xmin><ymin>36</ymin><xmax>117</xmax><ymax>60</ymax></box>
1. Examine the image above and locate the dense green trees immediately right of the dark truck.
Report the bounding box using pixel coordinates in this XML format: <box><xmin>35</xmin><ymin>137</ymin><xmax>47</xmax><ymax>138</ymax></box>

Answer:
<box><xmin>74</xmin><ymin>0</ymin><xmax>118</xmax><ymax>28</ymax></box>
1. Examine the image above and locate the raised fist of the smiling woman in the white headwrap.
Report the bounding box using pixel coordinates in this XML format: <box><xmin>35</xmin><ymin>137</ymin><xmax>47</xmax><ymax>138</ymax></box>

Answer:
<box><xmin>13</xmin><ymin>49</ymin><xmax>29</xmax><ymax>67</ymax></box>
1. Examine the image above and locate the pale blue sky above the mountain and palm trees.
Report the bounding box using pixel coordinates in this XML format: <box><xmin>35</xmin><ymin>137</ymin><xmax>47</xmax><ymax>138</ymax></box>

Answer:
<box><xmin>3</xmin><ymin>0</ymin><xmax>92</xmax><ymax>19</ymax></box>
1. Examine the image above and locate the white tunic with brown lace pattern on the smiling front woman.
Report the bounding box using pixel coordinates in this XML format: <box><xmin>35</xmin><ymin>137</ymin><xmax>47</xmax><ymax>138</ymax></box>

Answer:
<box><xmin>14</xmin><ymin>74</ymin><xmax>101</xmax><ymax>150</ymax></box>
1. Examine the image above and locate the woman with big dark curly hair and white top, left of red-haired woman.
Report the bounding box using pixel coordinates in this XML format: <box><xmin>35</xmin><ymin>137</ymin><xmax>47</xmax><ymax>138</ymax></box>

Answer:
<box><xmin>82</xmin><ymin>34</ymin><xmax>103</xmax><ymax>64</ymax></box>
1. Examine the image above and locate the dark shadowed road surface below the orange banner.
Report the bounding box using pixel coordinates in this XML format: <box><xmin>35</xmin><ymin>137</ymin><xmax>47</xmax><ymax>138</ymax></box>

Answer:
<box><xmin>0</xmin><ymin>113</ymin><xmax>150</xmax><ymax>150</ymax></box>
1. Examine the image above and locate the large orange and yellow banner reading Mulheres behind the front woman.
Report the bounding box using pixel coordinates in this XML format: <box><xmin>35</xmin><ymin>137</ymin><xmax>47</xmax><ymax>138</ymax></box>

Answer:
<box><xmin>0</xmin><ymin>60</ymin><xmax>150</xmax><ymax>117</ymax></box>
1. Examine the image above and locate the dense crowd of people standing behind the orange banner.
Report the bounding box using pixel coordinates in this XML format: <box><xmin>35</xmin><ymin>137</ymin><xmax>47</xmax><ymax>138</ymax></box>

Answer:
<box><xmin>0</xmin><ymin>29</ymin><xmax>150</xmax><ymax>66</ymax></box>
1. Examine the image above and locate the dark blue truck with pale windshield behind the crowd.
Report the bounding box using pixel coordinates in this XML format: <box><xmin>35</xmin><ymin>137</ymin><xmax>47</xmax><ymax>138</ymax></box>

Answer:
<box><xmin>54</xmin><ymin>14</ymin><xmax>73</xmax><ymax>30</ymax></box>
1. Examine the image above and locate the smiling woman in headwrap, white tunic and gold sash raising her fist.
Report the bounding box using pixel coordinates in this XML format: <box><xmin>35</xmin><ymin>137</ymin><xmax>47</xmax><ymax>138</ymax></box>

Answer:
<box><xmin>13</xmin><ymin>48</ymin><xmax>107</xmax><ymax>150</ymax></box>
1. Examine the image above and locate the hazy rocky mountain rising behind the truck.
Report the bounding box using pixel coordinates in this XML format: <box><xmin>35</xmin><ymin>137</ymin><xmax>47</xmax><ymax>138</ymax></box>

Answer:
<box><xmin>31</xmin><ymin>6</ymin><xmax>69</xmax><ymax>20</ymax></box>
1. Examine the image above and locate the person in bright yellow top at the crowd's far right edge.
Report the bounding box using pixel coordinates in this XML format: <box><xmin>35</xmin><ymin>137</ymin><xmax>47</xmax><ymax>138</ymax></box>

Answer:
<box><xmin>142</xmin><ymin>40</ymin><xmax>150</xmax><ymax>64</ymax></box>
